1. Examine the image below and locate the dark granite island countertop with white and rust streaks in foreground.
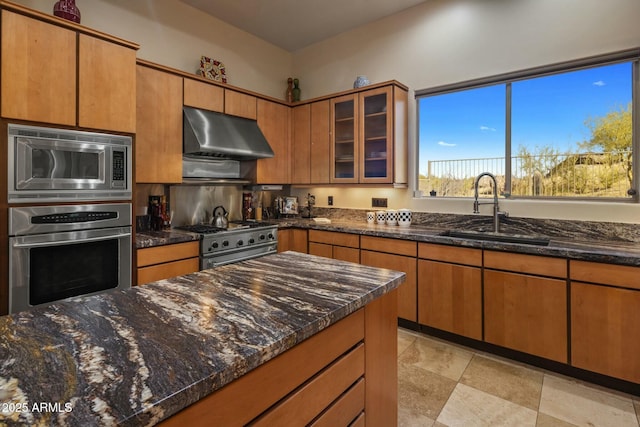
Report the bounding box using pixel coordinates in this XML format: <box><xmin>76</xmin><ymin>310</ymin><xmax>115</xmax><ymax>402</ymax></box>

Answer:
<box><xmin>0</xmin><ymin>252</ymin><xmax>405</xmax><ymax>426</ymax></box>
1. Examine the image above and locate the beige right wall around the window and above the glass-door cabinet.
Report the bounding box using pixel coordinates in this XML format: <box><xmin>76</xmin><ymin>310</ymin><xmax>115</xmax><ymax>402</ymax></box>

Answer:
<box><xmin>292</xmin><ymin>0</ymin><xmax>640</xmax><ymax>223</ymax></box>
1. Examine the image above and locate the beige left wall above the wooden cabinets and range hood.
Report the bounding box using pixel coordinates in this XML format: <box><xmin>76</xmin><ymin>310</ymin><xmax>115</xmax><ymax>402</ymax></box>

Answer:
<box><xmin>14</xmin><ymin>0</ymin><xmax>293</xmax><ymax>99</ymax></box>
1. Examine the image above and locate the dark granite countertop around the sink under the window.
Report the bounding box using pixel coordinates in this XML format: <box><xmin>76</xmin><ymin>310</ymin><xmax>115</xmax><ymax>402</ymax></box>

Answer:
<box><xmin>274</xmin><ymin>218</ymin><xmax>640</xmax><ymax>266</ymax></box>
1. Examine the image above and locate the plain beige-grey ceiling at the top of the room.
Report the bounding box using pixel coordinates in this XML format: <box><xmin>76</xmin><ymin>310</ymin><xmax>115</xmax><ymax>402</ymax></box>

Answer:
<box><xmin>181</xmin><ymin>0</ymin><xmax>426</xmax><ymax>52</ymax></box>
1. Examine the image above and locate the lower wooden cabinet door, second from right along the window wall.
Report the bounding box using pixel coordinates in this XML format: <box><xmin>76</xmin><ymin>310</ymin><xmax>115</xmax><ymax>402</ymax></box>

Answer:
<box><xmin>484</xmin><ymin>270</ymin><xmax>568</xmax><ymax>363</ymax></box>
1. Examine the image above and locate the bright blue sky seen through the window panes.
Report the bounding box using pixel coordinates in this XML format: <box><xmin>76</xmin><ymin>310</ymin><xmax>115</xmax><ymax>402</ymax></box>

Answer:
<box><xmin>419</xmin><ymin>63</ymin><xmax>632</xmax><ymax>173</ymax></box>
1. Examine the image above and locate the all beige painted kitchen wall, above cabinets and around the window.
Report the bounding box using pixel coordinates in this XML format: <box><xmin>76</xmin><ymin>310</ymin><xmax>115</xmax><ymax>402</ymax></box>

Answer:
<box><xmin>16</xmin><ymin>0</ymin><xmax>640</xmax><ymax>223</ymax></box>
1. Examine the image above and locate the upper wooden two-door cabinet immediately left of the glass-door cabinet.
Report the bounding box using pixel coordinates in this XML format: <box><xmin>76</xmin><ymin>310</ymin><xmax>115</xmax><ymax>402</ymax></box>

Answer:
<box><xmin>291</xmin><ymin>100</ymin><xmax>330</xmax><ymax>184</ymax></box>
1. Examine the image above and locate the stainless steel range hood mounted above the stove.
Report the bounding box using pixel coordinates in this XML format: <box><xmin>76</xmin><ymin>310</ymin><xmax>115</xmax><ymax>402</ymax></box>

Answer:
<box><xmin>183</xmin><ymin>107</ymin><xmax>274</xmax><ymax>160</ymax></box>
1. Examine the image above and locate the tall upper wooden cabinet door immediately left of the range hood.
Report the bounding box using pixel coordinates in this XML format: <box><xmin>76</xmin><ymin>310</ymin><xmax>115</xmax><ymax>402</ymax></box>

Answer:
<box><xmin>135</xmin><ymin>64</ymin><xmax>183</xmax><ymax>184</ymax></box>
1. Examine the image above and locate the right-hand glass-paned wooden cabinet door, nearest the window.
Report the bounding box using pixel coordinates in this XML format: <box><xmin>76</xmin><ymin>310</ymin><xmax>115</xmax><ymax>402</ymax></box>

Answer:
<box><xmin>360</xmin><ymin>88</ymin><xmax>393</xmax><ymax>183</ymax></box>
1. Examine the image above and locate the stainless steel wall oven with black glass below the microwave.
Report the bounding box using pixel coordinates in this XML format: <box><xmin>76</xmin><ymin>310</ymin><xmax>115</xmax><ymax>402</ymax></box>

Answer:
<box><xmin>9</xmin><ymin>203</ymin><xmax>132</xmax><ymax>313</ymax></box>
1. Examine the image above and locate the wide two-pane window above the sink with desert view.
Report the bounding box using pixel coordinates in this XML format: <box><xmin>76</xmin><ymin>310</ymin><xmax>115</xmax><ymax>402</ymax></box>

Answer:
<box><xmin>416</xmin><ymin>51</ymin><xmax>639</xmax><ymax>200</ymax></box>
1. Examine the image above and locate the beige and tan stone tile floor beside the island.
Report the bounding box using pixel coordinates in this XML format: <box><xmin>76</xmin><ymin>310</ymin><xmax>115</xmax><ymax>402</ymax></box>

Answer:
<box><xmin>398</xmin><ymin>328</ymin><xmax>640</xmax><ymax>427</ymax></box>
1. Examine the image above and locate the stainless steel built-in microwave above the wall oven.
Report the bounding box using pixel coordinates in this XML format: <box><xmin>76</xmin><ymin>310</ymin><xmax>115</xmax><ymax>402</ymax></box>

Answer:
<box><xmin>7</xmin><ymin>124</ymin><xmax>132</xmax><ymax>203</ymax></box>
